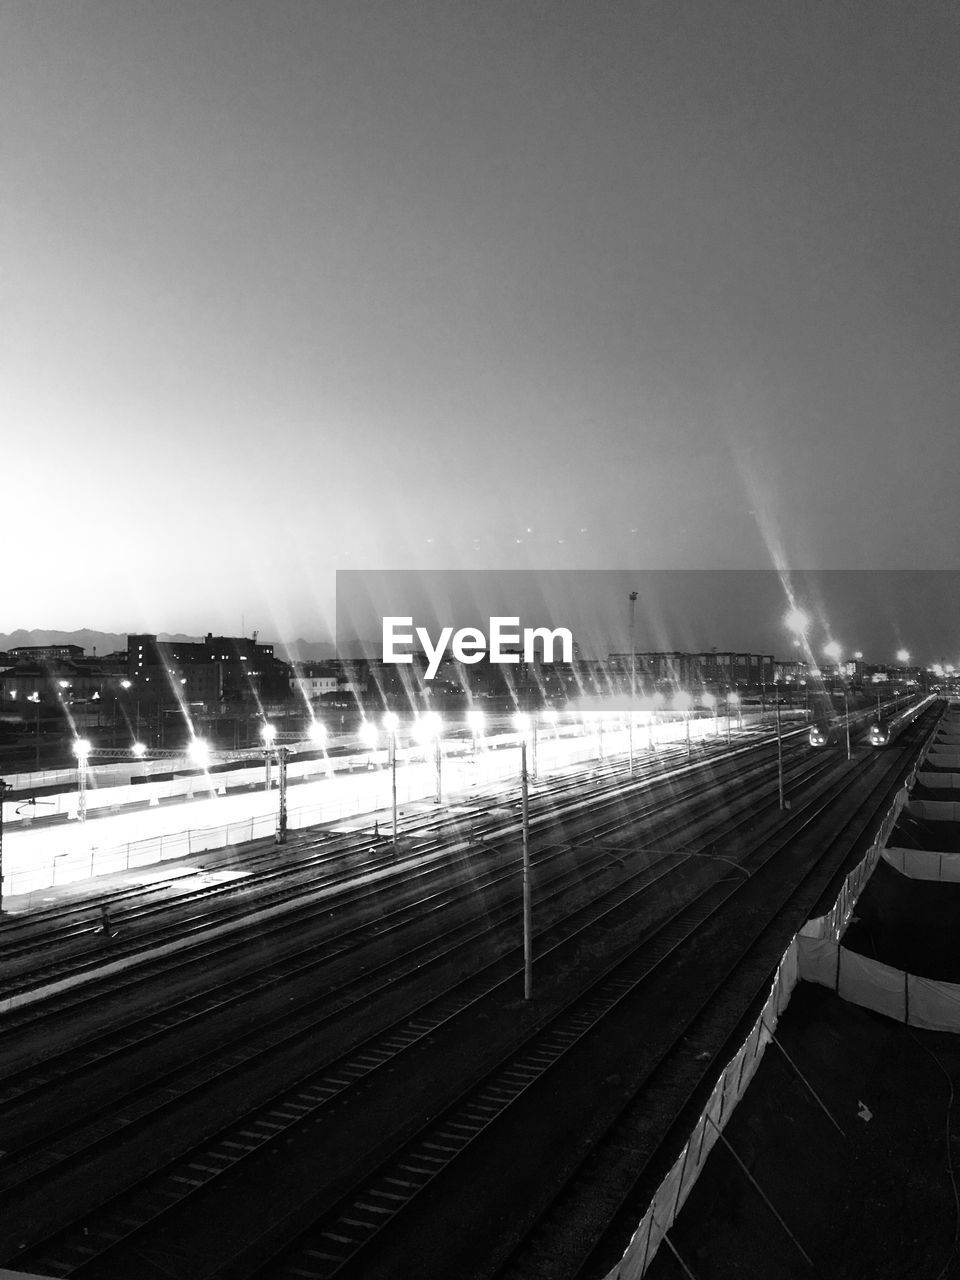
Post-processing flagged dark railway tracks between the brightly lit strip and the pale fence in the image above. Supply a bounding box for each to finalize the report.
[0,701,943,1280]
